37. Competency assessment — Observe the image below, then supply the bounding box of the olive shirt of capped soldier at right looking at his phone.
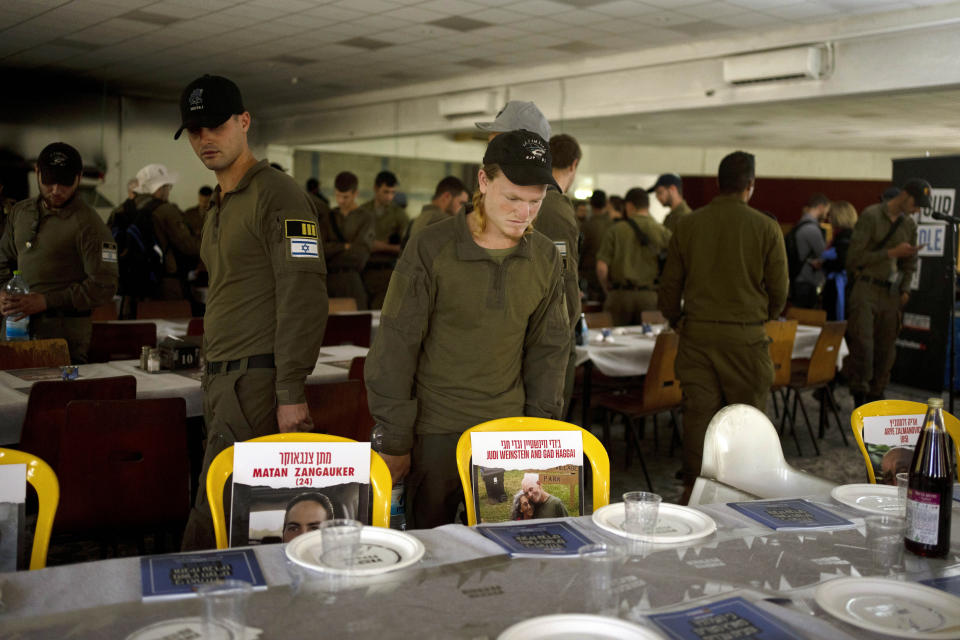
[847,202,917,293]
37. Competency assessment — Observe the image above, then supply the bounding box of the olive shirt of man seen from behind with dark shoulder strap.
[597,214,673,289]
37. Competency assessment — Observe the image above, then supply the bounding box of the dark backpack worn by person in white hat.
[110,199,164,298]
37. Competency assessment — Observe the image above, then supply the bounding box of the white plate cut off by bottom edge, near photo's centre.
[497,613,663,640]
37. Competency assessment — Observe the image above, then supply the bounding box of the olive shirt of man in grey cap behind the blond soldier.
[533,188,580,327]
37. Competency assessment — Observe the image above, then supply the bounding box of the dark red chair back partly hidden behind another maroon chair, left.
[20,376,137,470]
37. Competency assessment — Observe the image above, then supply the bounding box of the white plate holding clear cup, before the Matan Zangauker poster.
[284,527,425,576]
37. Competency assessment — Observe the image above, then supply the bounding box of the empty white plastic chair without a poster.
[690,404,836,504]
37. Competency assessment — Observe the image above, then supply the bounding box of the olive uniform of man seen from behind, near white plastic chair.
[659,195,788,485]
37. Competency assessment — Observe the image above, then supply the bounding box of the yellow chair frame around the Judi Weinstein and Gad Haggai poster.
[457,418,610,526]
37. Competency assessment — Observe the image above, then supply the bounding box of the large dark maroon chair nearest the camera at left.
[54,398,190,553]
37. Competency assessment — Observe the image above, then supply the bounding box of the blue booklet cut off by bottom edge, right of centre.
[650,598,802,640]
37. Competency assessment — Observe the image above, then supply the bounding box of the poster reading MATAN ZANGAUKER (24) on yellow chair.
[230,442,370,547]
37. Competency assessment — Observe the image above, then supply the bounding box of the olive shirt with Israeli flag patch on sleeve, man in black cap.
[200,160,327,404]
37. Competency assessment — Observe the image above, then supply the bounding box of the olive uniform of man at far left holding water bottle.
[0,197,118,364]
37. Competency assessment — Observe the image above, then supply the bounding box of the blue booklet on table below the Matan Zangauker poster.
[140,549,267,600]
